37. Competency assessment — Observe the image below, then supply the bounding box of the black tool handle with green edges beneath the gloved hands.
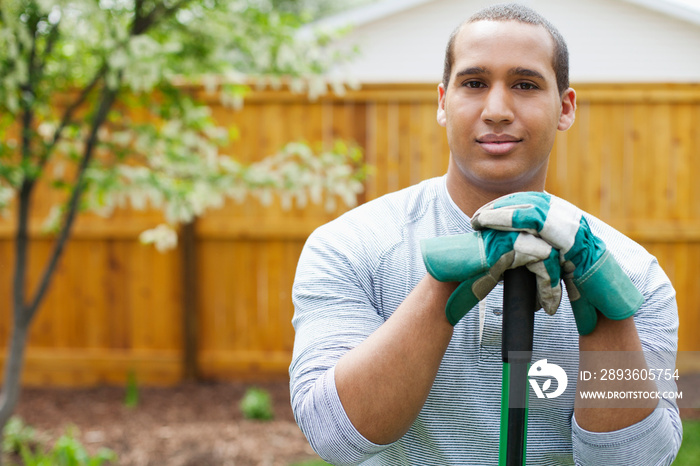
[501,267,537,466]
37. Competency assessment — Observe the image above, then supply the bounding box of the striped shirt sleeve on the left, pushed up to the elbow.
[290,224,394,465]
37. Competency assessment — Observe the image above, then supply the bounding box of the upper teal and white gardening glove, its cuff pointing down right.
[472,192,644,335]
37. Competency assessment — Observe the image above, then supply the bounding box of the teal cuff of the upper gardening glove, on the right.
[573,251,644,320]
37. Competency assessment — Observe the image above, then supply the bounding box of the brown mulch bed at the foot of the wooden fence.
[16,382,318,466]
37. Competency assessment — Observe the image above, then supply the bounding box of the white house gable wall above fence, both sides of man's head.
[328,0,700,83]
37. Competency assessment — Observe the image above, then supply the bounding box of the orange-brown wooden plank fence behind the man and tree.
[0,84,700,385]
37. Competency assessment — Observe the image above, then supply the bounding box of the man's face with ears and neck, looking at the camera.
[438,21,575,195]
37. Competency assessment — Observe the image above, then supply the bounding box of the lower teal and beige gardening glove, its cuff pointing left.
[421,230,561,325]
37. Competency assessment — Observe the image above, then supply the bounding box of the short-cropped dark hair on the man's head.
[442,3,569,94]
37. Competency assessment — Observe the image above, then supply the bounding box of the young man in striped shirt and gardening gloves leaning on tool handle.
[290,5,681,465]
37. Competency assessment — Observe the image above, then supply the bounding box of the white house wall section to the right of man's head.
[532,0,700,82]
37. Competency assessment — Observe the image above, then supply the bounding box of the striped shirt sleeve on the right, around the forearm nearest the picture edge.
[572,258,683,465]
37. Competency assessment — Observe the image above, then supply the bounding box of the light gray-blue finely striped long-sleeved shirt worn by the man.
[289,176,682,466]
